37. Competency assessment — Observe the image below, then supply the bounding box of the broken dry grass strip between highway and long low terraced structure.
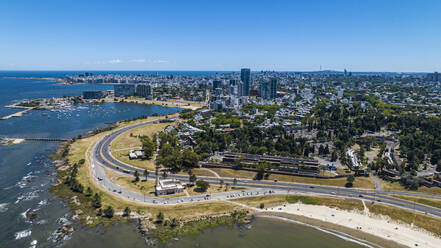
[210,168,375,189]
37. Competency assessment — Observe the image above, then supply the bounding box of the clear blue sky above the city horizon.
[0,0,441,72]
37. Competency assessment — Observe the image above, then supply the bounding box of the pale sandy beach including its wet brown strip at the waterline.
[256,203,441,248]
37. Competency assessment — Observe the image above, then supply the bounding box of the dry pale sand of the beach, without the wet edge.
[262,203,441,248]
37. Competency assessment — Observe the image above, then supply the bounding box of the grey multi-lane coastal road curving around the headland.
[90,117,441,218]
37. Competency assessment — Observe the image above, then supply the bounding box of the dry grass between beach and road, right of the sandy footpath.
[367,204,441,236]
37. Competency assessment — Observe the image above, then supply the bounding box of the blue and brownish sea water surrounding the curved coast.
[0,72,359,248]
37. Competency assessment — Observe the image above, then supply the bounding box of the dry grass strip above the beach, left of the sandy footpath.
[233,195,364,211]
